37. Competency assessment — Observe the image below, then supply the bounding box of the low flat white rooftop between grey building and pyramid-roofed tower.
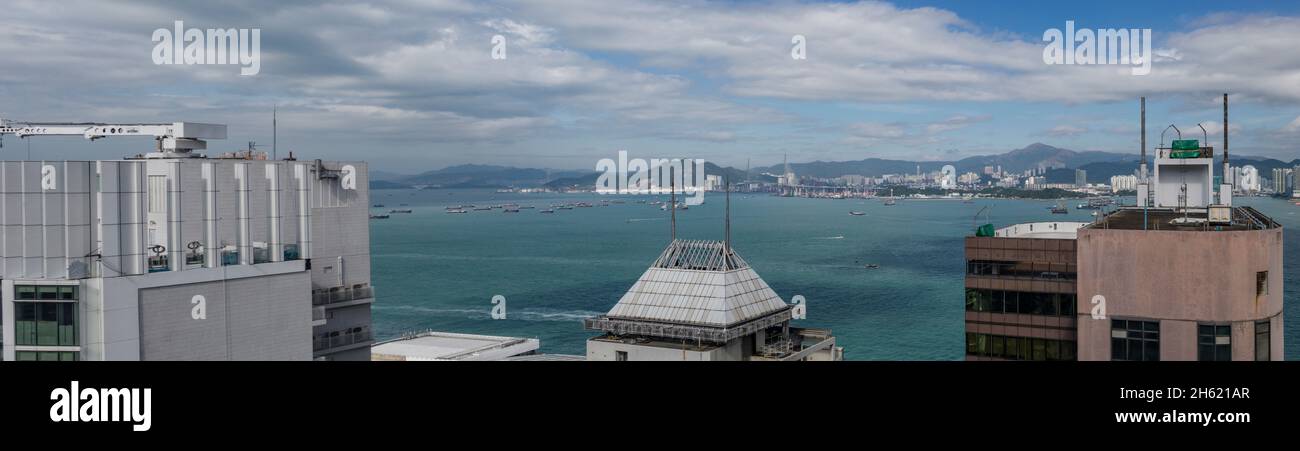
[371,331,541,360]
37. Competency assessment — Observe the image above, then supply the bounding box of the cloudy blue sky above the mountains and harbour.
[0,0,1300,173]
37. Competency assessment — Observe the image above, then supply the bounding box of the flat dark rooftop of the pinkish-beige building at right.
[1087,207,1282,231]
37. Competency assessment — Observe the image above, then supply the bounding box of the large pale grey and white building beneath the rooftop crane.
[0,157,373,360]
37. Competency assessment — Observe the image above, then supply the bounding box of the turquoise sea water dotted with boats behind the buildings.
[371,190,1300,360]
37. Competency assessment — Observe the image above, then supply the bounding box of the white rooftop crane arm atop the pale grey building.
[0,118,226,159]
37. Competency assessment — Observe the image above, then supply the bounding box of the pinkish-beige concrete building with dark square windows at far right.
[1076,207,1283,360]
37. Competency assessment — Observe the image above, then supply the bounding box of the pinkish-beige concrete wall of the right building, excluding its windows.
[1076,229,1284,360]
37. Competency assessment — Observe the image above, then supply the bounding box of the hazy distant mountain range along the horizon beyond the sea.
[371,143,1300,190]
